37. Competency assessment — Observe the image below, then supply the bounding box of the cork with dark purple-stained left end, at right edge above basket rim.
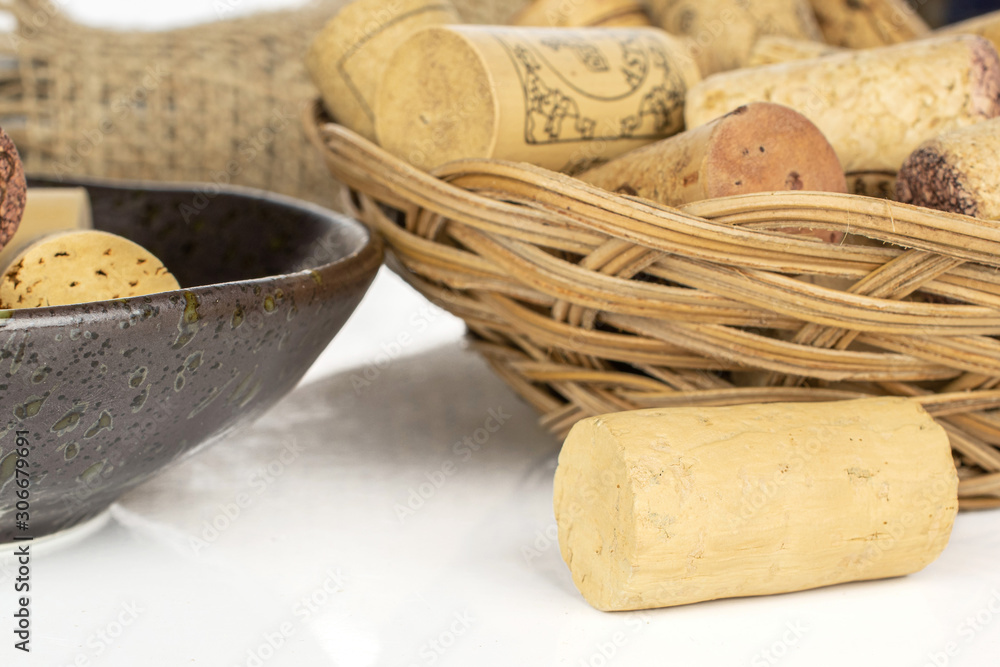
[896,118,1000,220]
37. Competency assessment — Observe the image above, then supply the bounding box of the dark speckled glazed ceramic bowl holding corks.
[0,180,382,543]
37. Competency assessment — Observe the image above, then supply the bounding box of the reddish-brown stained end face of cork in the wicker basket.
[705,102,847,197]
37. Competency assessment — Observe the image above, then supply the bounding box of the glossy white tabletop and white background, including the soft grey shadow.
[0,0,1000,667]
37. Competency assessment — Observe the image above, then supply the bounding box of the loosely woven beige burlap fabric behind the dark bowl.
[0,0,524,208]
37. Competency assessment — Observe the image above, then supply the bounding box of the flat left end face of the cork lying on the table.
[554,417,641,611]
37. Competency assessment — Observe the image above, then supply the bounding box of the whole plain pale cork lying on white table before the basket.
[554,398,958,611]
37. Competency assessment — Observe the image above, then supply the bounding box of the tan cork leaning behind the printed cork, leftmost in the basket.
[306,0,461,141]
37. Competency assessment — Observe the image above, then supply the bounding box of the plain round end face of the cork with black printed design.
[375,28,497,170]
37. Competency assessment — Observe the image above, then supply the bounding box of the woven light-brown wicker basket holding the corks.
[305,103,1000,509]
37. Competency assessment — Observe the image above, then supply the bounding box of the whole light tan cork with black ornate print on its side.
[376,26,700,172]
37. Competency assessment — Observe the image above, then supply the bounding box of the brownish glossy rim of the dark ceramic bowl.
[0,175,384,324]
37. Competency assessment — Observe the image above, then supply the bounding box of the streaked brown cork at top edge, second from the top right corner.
[809,0,930,49]
